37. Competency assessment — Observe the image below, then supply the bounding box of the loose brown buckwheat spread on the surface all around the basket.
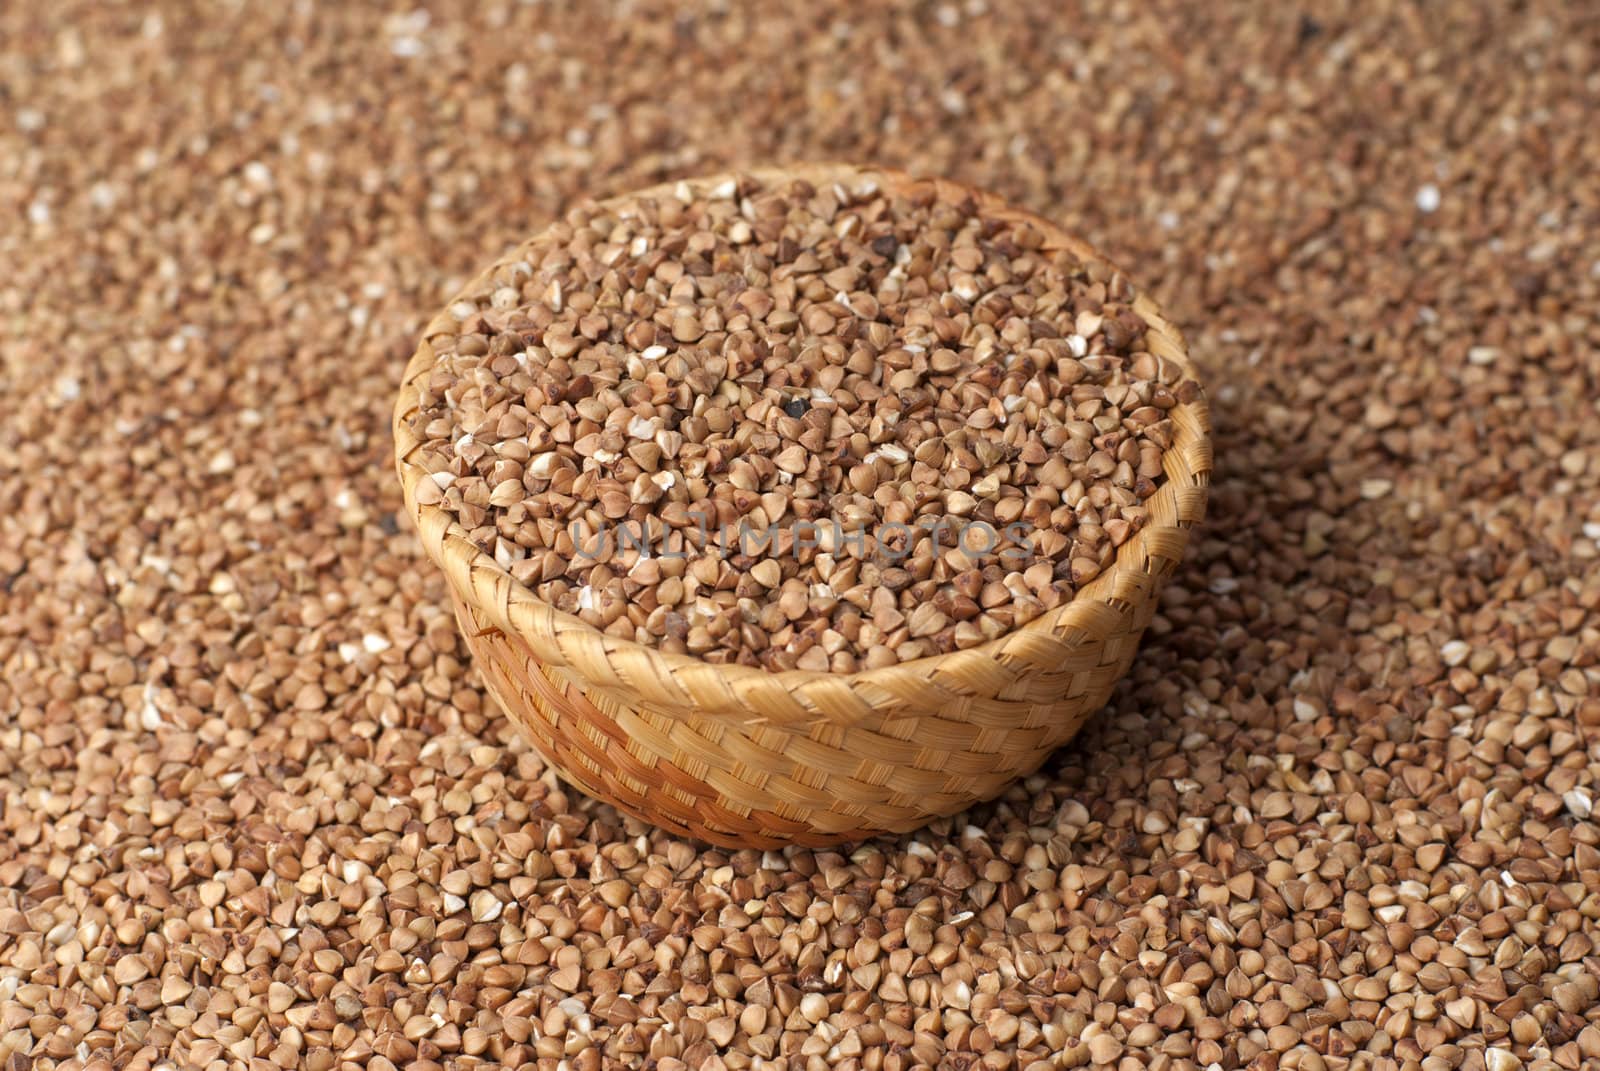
[0,0,1600,1071]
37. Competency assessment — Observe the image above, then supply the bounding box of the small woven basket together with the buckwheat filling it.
[394,165,1211,847]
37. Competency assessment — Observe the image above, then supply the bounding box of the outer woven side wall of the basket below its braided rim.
[454,596,1154,847]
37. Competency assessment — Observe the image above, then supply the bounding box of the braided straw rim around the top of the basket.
[392,162,1211,724]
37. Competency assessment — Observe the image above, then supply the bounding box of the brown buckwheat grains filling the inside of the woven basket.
[413,173,1197,662]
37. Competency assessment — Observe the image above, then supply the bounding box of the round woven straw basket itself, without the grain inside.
[394,165,1211,847]
